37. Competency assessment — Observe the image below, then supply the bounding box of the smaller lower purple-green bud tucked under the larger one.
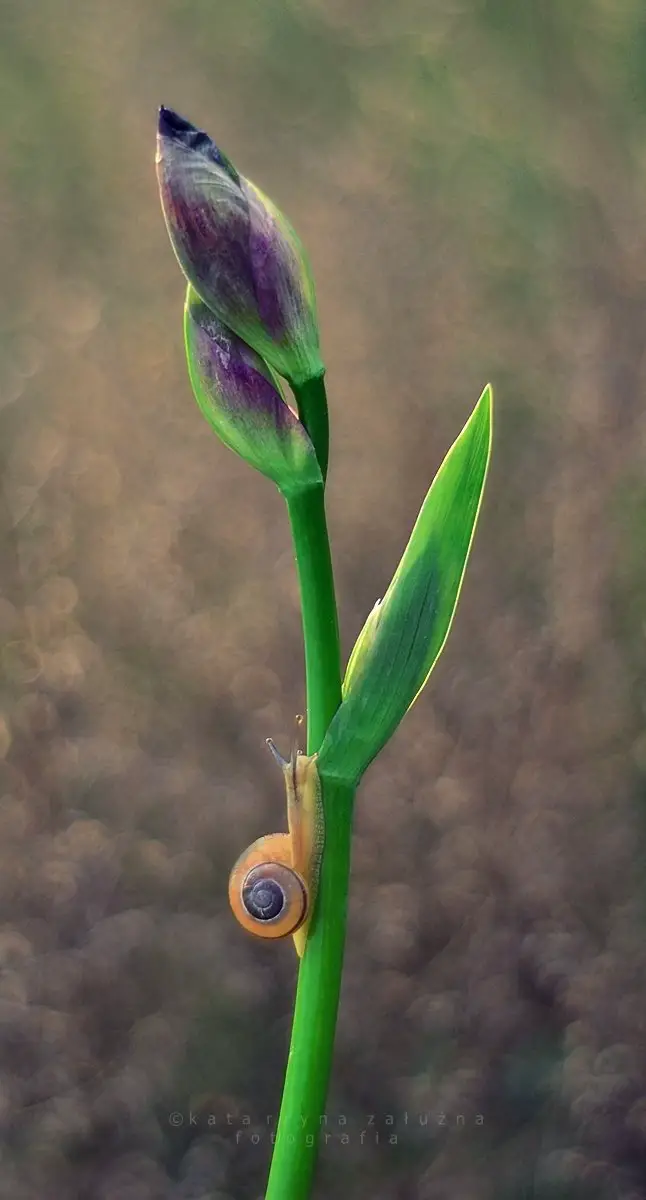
[184,286,323,496]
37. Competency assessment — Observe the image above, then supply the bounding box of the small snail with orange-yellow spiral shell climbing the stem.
[229,720,324,958]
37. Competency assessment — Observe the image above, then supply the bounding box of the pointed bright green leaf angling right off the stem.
[319,384,494,782]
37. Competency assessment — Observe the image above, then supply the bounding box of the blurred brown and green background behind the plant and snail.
[0,0,646,1200]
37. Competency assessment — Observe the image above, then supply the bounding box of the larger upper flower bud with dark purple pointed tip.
[156,108,324,384]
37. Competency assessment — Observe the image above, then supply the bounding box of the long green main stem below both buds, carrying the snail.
[265,486,354,1200]
